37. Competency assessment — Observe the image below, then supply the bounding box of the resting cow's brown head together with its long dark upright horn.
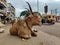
[26,2,41,26]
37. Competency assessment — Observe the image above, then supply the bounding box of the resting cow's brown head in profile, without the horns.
[26,14,41,27]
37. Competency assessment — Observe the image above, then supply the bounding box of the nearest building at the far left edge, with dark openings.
[0,0,7,21]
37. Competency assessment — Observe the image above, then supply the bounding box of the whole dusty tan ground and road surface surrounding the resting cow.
[0,23,60,45]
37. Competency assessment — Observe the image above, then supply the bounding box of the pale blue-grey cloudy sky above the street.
[7,0,60,17]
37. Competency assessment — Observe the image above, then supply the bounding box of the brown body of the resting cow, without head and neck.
[10,20,31,38]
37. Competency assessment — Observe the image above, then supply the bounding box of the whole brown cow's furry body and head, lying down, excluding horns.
[10,14,40,38]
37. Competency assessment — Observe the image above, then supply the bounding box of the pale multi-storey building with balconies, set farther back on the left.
[7,3,15,20]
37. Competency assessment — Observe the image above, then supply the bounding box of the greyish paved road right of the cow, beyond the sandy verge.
[35,23,60,38]
